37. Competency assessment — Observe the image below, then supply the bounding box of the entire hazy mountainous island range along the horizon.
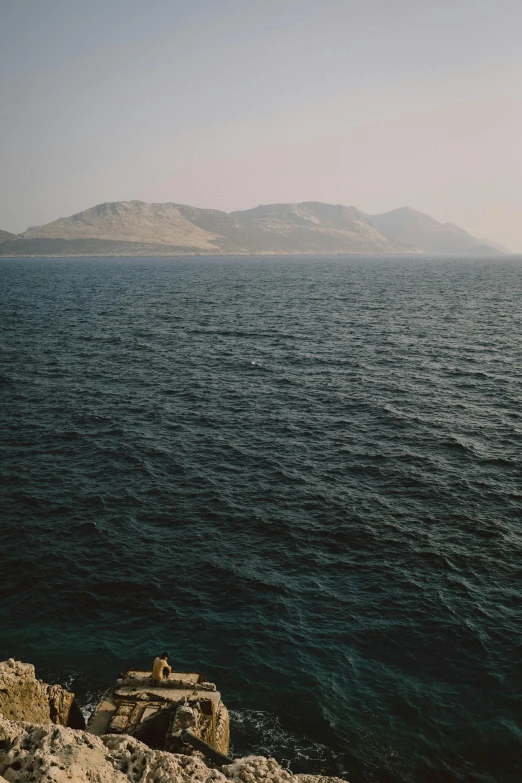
[0,201,509,257]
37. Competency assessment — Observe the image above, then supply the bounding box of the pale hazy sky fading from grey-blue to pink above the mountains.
[0,0,522,252]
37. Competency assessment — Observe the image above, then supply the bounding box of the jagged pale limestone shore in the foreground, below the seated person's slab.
[0,660,345,783]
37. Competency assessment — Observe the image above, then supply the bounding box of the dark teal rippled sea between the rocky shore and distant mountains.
[0,258,522,783]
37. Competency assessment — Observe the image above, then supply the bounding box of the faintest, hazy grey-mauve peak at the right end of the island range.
[368,207,502,255]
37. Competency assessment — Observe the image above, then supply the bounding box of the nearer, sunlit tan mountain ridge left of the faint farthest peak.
[0,201,408,255]
